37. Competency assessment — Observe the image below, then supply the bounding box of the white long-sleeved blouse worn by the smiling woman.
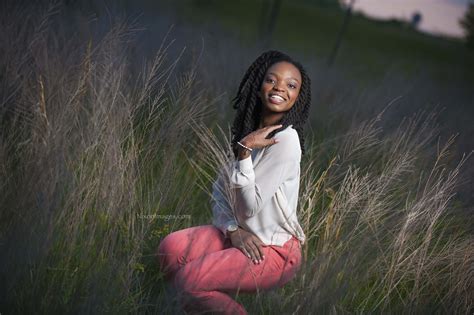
[211,125,305,246]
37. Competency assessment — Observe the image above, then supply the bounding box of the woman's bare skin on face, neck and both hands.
[229,61,301,264]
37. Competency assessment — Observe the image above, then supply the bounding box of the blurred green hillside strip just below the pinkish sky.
[174,0,474,83]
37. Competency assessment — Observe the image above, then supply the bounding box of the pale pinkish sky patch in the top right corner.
[344,0,474,37]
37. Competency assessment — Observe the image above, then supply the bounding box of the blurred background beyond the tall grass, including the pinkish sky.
[65,0,474,201]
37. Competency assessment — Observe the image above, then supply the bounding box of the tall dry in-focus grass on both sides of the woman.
[0,1,474,314]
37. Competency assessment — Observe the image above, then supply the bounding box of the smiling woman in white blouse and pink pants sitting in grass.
[158,51,311,314]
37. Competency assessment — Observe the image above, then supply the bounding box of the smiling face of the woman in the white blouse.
[260,61,302,113]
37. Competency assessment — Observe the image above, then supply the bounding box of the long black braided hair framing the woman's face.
[232,50,311,158]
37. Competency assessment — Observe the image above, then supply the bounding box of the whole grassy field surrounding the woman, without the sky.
[0,1,474,314]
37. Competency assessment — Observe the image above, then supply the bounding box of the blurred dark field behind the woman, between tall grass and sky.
[169,0,474,204]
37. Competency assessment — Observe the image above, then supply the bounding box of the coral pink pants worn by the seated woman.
[157,225,301,314]
